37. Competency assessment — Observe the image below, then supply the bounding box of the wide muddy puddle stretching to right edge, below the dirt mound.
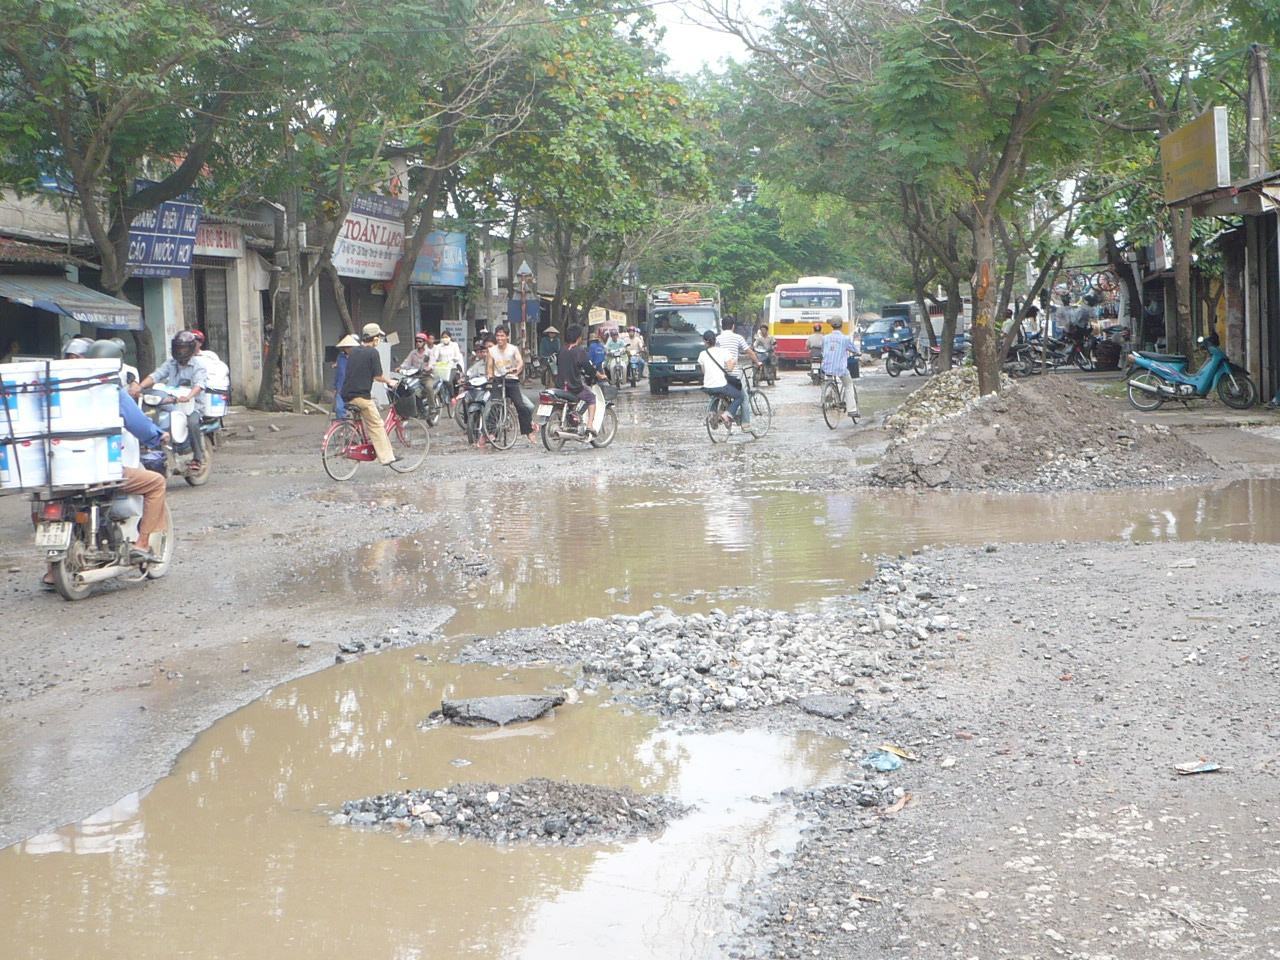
[296,480,1280,634]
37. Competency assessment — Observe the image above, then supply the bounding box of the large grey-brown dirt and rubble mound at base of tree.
[873,371,1219,490]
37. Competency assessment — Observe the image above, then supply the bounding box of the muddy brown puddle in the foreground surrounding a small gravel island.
[0,650,845,960]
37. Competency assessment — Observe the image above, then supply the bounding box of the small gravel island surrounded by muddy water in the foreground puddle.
[332,778,687,844]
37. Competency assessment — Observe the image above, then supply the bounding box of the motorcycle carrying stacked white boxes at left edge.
[31,484,174,600]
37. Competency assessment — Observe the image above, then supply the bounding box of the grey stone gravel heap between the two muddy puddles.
[465,562,954,714]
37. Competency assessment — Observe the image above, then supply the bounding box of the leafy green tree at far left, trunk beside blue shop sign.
[0,0,282,367]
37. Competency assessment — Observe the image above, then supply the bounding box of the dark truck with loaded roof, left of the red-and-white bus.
[643,283,721,394]
